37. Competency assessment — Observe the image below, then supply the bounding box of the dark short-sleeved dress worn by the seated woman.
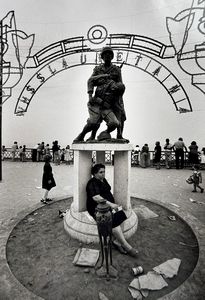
[86,177,127,228]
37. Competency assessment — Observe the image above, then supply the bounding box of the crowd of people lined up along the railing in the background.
[2,137,205,169]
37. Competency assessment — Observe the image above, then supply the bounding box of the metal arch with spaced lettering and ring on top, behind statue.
[14,25,192,116]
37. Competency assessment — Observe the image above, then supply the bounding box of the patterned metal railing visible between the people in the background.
[3,148,205,168]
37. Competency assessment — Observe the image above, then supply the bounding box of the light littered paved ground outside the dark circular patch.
[0,161,205,300]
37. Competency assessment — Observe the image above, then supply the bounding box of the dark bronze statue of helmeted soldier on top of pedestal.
[73,47,128,143]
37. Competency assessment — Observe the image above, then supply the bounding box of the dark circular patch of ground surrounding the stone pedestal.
[6,198,199,300]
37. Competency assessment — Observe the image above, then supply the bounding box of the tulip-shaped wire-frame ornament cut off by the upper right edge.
[166,0,205,94]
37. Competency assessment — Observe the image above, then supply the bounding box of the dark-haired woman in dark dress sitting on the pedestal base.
[86,164,138,257]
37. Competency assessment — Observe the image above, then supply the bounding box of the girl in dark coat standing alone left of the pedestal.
[41,155,56,204]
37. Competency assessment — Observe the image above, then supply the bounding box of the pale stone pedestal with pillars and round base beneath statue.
[64,143,138,243]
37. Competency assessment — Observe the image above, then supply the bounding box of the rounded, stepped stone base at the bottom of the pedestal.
[64,203,138,244]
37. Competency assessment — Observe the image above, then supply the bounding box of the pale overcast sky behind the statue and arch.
[0,0,205,150]
